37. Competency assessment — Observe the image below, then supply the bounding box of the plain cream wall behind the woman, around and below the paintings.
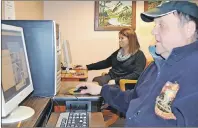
[44,1,152,81]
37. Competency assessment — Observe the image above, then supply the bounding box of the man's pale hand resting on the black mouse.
[76,82,102,95]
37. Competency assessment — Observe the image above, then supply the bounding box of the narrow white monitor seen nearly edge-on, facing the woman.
[62,40,72,68]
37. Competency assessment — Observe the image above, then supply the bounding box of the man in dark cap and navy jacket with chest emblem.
[77,1,198,127]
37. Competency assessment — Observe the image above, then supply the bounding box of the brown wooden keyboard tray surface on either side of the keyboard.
[46,112,105,128]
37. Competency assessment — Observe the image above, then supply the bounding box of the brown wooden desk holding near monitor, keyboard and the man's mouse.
[2,82,105,128]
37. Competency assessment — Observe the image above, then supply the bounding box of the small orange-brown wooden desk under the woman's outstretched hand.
[61,69,88,81]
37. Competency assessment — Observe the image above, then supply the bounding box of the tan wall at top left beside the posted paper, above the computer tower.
[2,1,44,20]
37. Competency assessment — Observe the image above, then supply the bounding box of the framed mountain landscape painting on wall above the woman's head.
[94,1,136,31]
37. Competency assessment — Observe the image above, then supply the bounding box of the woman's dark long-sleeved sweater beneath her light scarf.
[87,49,146,84]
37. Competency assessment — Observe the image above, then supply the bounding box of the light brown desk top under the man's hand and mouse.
[54,81,101,100]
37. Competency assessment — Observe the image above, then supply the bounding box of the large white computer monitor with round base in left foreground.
[1,24,34,124]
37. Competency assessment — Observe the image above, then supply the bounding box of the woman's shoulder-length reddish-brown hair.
[119,28,140,54]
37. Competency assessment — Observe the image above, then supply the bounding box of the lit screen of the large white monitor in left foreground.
[1,30,30,102]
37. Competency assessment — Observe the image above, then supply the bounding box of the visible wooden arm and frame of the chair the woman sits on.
[102,59,153,127]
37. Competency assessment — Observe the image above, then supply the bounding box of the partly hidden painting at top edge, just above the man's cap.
[144,0,163,11]
